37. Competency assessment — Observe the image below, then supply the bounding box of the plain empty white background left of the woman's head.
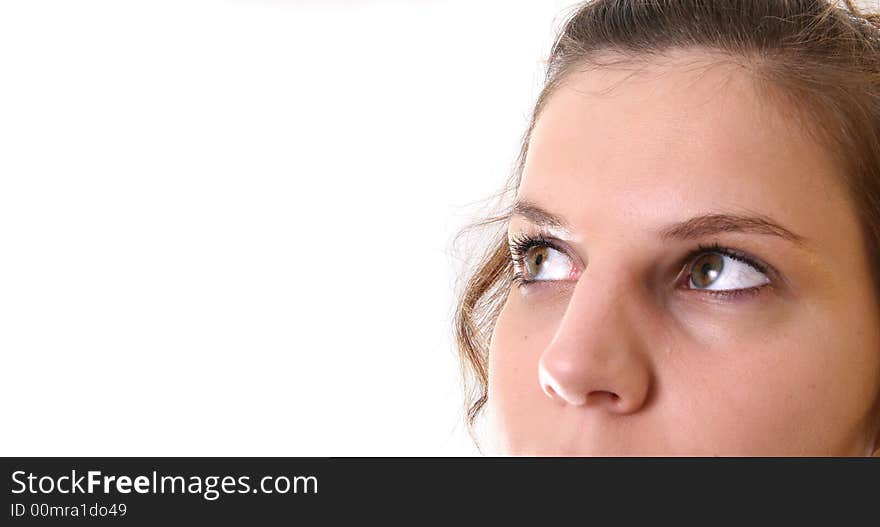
[0,0,572,456]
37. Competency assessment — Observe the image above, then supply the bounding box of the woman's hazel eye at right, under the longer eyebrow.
[688,250,770,291]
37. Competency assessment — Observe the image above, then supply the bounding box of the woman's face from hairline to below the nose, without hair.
[488,51,880,455]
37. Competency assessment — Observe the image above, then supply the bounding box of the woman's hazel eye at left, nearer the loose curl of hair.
[510,236,575,284]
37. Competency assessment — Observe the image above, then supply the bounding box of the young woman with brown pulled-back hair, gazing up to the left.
[456,0,880,456]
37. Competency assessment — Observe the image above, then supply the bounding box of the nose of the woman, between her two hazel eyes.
[538,271,652,414]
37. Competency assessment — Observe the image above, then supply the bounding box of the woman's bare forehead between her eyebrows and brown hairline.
[519,51,849,241]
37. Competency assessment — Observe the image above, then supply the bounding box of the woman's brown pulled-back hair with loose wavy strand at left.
[454,0,880,446]
